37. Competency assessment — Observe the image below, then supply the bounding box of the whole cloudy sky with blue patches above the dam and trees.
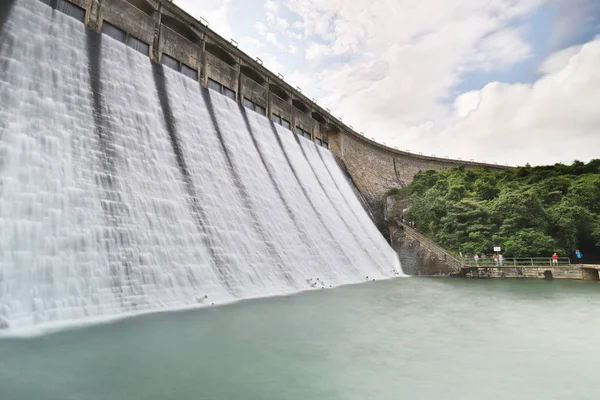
[175,0,600,165]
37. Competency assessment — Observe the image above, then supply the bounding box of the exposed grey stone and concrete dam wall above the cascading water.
[32,0,503,199]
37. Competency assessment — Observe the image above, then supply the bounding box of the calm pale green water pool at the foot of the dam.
[0,278,600,400]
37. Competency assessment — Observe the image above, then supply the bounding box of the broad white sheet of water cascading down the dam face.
[0,0,400,330]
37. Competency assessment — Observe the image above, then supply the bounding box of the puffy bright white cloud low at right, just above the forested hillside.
[436,39,600,165]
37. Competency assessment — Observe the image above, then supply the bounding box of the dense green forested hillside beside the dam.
[392,160,600,262]
